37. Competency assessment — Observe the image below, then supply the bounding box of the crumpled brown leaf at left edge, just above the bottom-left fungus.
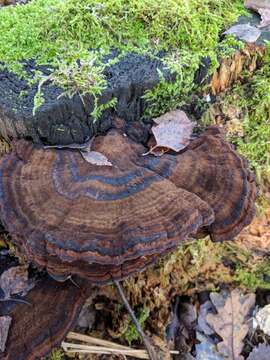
[0,266,33,299]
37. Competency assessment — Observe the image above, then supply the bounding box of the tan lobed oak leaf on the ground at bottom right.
[206,289,255,360]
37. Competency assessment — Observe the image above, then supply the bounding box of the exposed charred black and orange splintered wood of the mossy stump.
[0,14,270,144]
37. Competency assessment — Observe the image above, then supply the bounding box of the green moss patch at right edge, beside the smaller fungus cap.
[227,46,270,179]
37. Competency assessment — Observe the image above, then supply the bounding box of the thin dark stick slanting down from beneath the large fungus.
[113,280,158,360]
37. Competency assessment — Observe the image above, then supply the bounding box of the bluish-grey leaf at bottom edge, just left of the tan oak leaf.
[195,332,225,360]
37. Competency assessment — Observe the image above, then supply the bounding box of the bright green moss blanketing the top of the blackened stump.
[0,0,245,114]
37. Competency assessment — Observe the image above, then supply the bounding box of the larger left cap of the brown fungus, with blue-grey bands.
[0,130,214,283]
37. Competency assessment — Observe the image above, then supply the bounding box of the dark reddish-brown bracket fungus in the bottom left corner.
[0,276,91,360]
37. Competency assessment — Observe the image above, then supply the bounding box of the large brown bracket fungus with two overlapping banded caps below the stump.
[0,127,257,359]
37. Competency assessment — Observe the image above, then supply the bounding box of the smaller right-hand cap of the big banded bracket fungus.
[141,126,258,241]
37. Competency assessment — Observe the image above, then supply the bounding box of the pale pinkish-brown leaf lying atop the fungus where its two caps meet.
[150,110,194,155]
